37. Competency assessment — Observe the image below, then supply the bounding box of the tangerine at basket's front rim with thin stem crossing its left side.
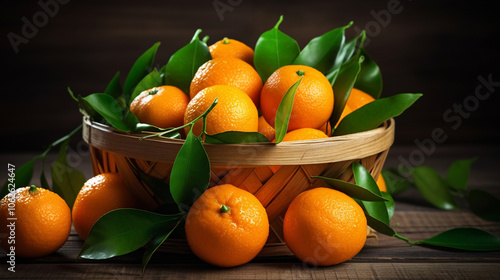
[184,85,259,136]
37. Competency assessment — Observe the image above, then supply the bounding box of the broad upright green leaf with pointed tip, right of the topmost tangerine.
[253,16,300,82]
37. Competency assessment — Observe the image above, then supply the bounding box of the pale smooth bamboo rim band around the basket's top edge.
[82,116,396,166]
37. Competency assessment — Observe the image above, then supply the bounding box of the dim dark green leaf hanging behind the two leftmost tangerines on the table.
[50,138,86,209]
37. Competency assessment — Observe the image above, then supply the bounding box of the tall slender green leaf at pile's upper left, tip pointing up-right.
[123,42,160,103]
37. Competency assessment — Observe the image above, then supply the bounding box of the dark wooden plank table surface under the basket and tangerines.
[0,145,500,280]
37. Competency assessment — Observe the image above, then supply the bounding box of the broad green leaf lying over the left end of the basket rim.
[83,93,130,132]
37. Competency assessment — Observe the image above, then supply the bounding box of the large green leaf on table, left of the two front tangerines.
[78,208,182,259]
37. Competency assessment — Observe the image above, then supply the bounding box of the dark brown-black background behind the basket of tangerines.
[0,0,500,152]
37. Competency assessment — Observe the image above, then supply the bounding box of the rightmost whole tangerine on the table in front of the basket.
[283,188,367,266]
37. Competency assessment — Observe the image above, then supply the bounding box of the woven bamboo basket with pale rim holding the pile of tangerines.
[83,118,395,256]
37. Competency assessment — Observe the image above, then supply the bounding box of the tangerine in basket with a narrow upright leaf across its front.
[260,65,333,131]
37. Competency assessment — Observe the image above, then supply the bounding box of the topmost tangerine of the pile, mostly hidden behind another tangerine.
[208,37,254,65]
